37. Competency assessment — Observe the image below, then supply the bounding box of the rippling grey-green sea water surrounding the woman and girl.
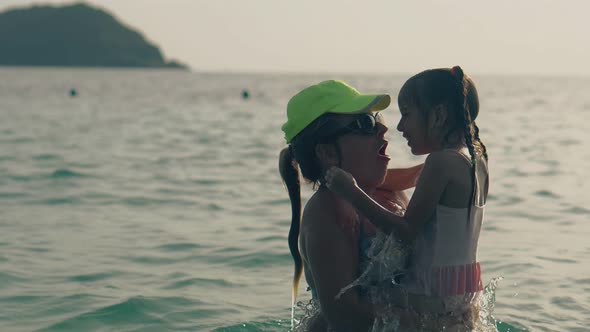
[0,68,590,331]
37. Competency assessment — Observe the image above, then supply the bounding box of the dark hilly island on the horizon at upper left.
[0,3,186,68]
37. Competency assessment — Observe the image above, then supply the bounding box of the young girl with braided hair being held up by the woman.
[326,66,489,330]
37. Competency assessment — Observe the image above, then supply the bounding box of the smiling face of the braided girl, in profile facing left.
[397,103,432,155]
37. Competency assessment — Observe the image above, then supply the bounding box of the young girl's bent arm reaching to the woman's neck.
[326,152,454,242]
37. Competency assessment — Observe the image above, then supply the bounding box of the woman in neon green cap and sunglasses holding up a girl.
[279,80,421,331]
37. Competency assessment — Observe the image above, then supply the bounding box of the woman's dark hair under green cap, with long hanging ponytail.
[279,113,342,305]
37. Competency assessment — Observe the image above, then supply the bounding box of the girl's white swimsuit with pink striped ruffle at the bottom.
[402,152,488,297]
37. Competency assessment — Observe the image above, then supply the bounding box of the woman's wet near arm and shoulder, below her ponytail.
[302,191,374,331]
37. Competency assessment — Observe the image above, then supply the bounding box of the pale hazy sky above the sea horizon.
[0,0,590,76]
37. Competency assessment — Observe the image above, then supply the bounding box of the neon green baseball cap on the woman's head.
[281,80,391,143]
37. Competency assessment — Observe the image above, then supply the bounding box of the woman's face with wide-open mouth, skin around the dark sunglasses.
[336,113,390,190]
